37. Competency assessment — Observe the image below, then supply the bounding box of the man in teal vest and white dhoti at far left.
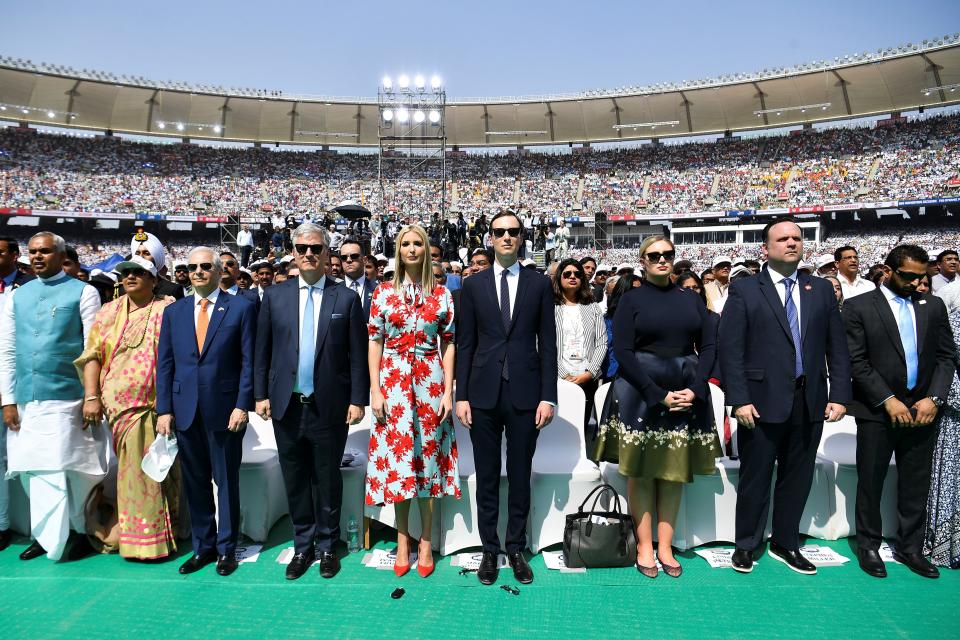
[0,232,108,560]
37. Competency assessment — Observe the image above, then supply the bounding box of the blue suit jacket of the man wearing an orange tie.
[157,291,257,431]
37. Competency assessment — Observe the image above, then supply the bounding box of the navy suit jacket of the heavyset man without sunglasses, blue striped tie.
[719,267,853,423]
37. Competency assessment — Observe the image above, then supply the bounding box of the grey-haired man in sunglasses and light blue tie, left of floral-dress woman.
[254,223,370,580]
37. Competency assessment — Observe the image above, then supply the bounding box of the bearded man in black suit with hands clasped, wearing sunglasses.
[843,244,956,578]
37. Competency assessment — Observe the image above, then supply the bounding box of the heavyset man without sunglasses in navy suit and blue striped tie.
[719,219,852,574]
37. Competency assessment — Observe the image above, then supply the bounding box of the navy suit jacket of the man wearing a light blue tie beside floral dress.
[254,278,370,428]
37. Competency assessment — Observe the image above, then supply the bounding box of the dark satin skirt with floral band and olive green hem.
[591,352,723,483]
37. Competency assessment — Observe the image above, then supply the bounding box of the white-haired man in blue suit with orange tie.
[157,247,257,576]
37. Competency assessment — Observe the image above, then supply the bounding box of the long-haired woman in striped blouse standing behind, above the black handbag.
[553,258,607,437]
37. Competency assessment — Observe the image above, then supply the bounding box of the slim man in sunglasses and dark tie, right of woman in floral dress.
[457,211,557,584]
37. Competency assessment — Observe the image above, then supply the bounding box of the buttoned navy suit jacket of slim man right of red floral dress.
[457,267,557,410]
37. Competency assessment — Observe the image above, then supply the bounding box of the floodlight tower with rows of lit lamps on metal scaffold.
[377,73,447,219]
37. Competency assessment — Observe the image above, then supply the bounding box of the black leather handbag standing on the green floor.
[563,484,637,569]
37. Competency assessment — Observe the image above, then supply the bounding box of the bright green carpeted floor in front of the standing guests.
[0,520,960,640]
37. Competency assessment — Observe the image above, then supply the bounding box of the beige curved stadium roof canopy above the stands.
[0,34,960,147]
